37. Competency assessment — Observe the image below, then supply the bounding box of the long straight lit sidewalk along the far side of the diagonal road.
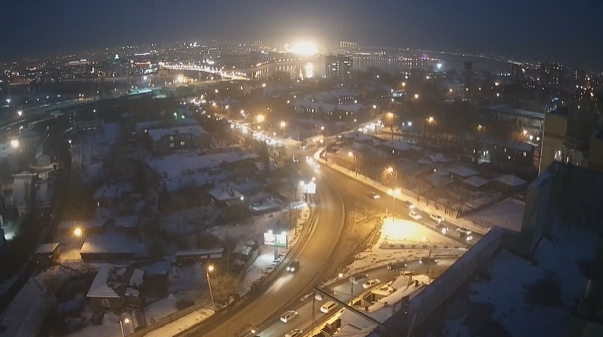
[314,150,492,235]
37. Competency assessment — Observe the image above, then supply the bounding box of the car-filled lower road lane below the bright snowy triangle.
[256,258,457,337]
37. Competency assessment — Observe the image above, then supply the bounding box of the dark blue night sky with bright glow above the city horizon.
[0,0,603,69]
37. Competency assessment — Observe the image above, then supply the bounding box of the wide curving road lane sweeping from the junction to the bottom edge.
[196,171,344,337]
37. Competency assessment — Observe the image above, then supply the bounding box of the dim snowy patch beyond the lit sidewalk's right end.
[465,198,525,232]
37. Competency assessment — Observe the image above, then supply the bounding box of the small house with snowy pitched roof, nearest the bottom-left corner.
[86,265,144,311]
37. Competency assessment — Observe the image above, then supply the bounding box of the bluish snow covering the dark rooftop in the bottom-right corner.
[462,225,597,336]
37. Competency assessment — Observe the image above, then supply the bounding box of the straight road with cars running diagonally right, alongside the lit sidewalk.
[321,165,482,245]
